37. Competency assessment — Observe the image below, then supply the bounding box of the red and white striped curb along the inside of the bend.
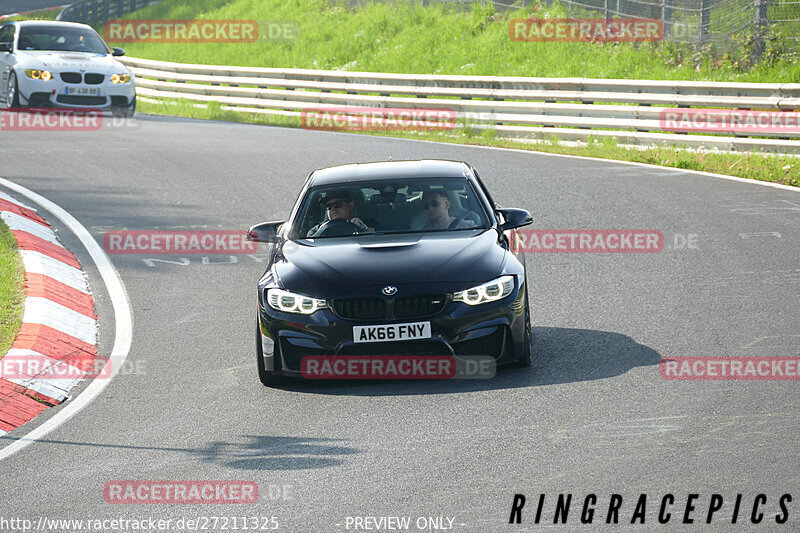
[0,192,97,436]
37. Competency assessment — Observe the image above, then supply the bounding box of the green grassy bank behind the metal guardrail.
[109,0,800,82]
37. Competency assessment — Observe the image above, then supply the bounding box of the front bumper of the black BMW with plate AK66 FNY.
[258,283,526,376]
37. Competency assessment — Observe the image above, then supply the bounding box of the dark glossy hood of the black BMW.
[273,230,507,297]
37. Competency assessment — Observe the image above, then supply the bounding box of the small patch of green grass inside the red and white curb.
[0,220,25,357]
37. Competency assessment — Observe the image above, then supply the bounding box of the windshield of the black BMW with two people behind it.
[293,178,489,239]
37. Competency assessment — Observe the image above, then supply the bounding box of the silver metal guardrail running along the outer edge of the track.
[121,57,800,154]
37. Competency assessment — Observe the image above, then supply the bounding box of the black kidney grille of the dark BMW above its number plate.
[333,294,447,320]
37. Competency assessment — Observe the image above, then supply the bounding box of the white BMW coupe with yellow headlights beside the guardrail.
[0,21,136,117]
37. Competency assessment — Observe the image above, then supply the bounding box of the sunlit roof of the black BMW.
[312,159,470,185]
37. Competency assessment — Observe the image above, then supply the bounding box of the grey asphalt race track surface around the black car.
[0,117,800,532]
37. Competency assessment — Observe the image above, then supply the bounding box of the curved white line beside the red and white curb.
[0,178,133,461]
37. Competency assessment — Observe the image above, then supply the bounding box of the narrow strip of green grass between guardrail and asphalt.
[137,100,800,187]
